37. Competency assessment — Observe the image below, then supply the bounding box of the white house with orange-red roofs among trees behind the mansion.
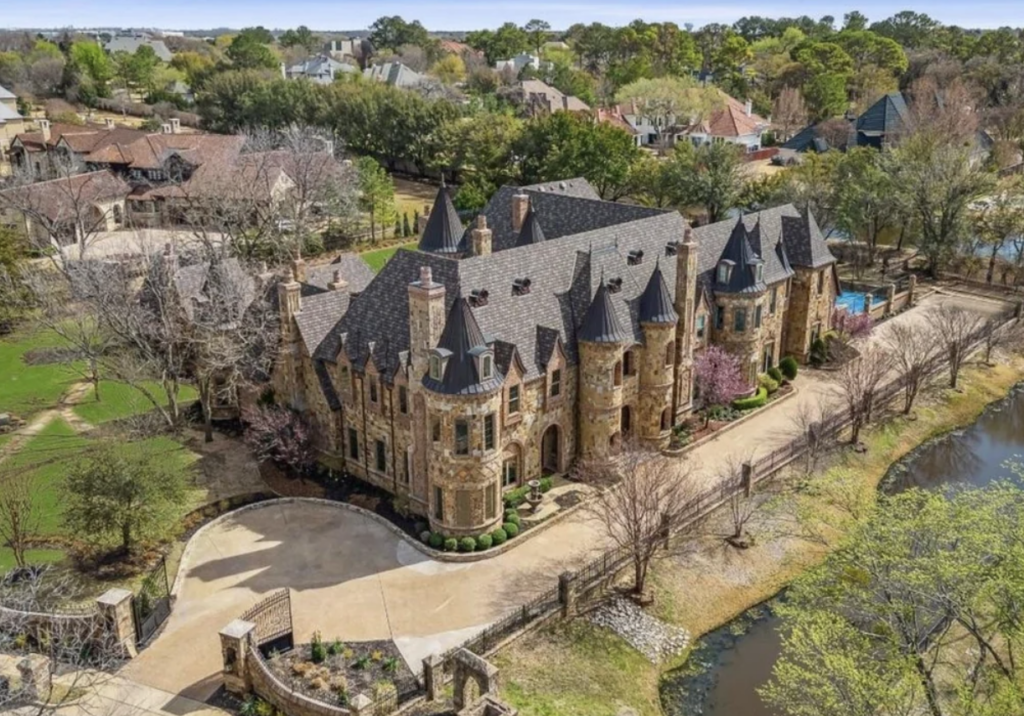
[601,91,770,153]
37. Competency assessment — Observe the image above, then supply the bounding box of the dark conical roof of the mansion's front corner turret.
[423,296,504,395]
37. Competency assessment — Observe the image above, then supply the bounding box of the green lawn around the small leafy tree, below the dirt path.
[0,418,205,573]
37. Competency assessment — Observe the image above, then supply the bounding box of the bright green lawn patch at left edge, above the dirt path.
[0,331,79,419]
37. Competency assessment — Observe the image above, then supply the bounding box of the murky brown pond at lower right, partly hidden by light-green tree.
[662,386,1024,716]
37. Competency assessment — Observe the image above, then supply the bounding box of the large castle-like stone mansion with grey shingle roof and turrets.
[273,179,837,537]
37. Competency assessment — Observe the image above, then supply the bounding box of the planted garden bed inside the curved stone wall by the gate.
[267,639,419,706]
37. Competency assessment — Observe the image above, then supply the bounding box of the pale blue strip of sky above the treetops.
[0,0,1024,31]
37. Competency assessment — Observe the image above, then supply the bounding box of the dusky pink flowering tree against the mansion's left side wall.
[242,406,316,477]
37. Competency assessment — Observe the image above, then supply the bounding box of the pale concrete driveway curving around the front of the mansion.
[125,295,1005,700]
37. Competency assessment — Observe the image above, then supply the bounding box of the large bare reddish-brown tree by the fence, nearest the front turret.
[578,443,695,597]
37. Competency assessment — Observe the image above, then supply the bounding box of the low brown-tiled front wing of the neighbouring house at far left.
[0,171,131,247]
